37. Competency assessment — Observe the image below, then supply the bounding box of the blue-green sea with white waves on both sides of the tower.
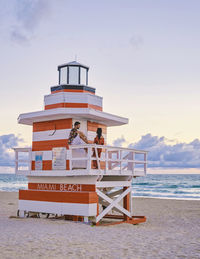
[0,174,200,200]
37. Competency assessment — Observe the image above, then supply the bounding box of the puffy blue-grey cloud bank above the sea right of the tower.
[121,134,200,168]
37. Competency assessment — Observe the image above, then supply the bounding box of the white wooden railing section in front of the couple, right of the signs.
[69,144,148,175]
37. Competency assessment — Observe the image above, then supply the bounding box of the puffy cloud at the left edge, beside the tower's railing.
[0,134,23,166]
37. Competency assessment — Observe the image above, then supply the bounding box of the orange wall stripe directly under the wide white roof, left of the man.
[33,119,72,132]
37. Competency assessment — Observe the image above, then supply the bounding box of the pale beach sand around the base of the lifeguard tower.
[0,192,200,259]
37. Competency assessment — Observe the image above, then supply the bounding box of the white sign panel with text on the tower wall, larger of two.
[52,147,66,170]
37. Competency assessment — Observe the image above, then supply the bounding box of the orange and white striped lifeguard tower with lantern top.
[14,61,147,225]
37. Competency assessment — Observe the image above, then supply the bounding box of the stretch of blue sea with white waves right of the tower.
[132,174,200,200]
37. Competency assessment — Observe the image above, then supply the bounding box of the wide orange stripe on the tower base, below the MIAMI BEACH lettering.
[19,190,98,204]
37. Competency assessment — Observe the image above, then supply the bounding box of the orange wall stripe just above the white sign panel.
[32,139,68,151]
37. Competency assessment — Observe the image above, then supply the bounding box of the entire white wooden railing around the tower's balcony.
[13,144,148,176]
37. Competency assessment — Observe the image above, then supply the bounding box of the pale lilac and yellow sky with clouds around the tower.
[0,0,200,174]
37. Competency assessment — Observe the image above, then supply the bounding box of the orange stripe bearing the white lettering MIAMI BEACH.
[28,183,96,192]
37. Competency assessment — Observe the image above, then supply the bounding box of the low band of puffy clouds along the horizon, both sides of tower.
[0,134,200,168]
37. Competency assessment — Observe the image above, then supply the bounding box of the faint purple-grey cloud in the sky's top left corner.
[0,0,53,44]
